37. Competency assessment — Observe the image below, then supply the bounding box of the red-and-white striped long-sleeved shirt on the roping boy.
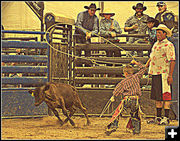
[113,63,146,96]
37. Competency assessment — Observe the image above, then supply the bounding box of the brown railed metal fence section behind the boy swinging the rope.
[72,34,154,115]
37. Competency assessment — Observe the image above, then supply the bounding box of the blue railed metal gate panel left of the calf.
[1,30,49,117]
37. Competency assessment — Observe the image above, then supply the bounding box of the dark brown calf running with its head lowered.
[29,82,90,126]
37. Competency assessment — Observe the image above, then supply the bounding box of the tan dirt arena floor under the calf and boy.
[1,116,178,140]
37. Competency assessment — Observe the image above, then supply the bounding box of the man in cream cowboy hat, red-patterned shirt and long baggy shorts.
[147,24,176,125]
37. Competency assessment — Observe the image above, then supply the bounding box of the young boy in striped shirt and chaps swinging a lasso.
[105,59,149,136]
